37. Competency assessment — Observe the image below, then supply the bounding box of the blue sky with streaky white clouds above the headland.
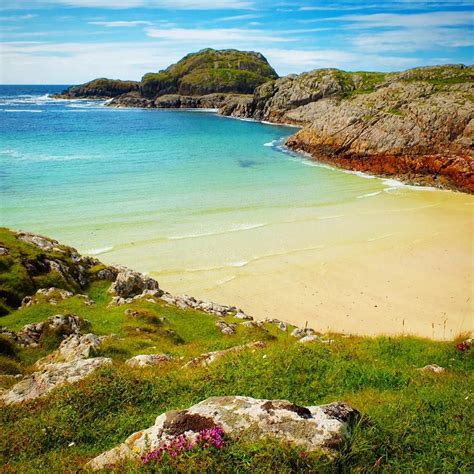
[0,0,474,84]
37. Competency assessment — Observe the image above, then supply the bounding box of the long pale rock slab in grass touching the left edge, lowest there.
[0,357,112,405]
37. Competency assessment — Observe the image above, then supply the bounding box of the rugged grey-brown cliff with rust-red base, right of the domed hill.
[220,65,474,192]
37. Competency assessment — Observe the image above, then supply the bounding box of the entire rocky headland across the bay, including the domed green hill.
[53,49,474,193]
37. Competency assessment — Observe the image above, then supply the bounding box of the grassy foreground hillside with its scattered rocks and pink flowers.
[0,229,474,473]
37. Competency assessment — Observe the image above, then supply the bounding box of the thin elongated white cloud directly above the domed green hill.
[145,28,292,42]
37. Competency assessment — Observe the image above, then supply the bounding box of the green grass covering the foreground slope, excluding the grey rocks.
[0,229,474,472]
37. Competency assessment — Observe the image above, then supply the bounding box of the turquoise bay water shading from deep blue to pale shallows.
[0,86,386,272]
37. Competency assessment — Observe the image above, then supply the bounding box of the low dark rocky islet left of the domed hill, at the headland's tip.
[53,78,140,100]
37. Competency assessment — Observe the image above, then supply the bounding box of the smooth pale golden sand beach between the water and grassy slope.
[147,188,474,340]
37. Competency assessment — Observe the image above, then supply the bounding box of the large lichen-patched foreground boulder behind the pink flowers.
[85,396,359,470]
